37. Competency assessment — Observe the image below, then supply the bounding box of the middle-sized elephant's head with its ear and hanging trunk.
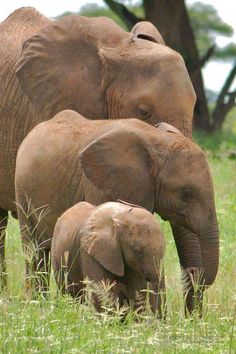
[80,119,219,311]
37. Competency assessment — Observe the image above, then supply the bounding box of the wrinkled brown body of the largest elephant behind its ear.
[0,8,51,211]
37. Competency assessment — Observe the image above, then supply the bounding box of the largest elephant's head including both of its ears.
[16,16,195,136]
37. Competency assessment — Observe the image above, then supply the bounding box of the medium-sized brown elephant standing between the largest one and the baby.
[16,111,219,311]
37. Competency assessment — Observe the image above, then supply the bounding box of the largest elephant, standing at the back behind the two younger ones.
[0,8,195,284]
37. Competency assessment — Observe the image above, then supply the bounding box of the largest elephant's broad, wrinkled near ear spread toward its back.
[16,16,103,118]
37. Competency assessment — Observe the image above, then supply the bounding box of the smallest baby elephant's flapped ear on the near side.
[82,216,124,277]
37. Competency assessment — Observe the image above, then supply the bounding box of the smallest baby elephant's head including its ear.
[82,202,165,286]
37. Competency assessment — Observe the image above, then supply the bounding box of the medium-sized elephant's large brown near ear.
[80,123,155,211]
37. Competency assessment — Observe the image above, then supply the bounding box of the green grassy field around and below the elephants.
[0,133,236,354]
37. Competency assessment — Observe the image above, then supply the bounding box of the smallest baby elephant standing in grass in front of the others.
[51,202,165,317]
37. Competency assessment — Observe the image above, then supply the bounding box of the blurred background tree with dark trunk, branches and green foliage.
[59,0,236,132]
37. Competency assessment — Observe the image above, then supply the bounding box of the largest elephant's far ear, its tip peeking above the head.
[131,21,165,45]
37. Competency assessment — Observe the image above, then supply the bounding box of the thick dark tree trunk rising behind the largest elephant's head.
[143,0,210,132]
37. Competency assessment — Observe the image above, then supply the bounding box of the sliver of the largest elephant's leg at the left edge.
[0,209,8,289]
